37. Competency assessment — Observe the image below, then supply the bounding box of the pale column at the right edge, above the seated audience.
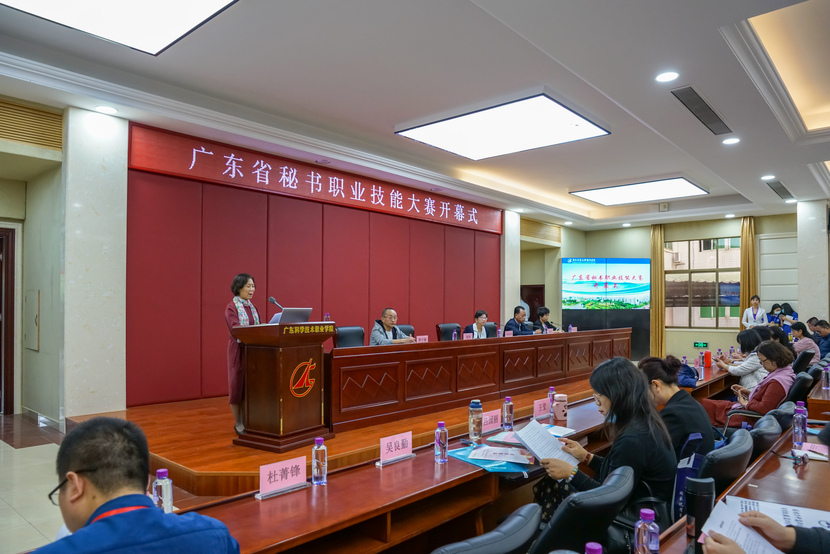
[798,200,830,321]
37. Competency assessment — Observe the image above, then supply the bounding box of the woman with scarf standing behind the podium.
[225,273,259,435]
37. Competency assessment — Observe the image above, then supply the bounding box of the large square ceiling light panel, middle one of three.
[395,93,608,160]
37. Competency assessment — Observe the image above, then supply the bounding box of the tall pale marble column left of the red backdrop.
[64,108,128,417]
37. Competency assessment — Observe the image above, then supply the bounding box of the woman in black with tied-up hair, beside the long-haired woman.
[638,356,715,461]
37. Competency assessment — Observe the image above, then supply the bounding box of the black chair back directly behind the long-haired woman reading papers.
[529,466,635,554]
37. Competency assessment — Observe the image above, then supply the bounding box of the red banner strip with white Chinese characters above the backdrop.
[129,124,502,234]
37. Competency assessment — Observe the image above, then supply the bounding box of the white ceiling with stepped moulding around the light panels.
[0,0,830,229]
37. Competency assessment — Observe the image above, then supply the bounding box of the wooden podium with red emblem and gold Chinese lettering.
[231,321,334,453]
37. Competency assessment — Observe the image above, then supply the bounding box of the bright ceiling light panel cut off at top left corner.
[0,0,237,56]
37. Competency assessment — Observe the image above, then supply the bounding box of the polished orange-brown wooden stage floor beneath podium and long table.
[71,379,591,496]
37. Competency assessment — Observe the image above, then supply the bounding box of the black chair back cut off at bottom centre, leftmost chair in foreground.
[432,504,542,554]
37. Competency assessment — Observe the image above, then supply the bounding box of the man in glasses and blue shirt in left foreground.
[36,417,239,554]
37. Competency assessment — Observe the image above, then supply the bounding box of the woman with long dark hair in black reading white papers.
[533,357,677,521]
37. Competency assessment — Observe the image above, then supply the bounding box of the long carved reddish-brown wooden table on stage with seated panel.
[326,327,631,432]
